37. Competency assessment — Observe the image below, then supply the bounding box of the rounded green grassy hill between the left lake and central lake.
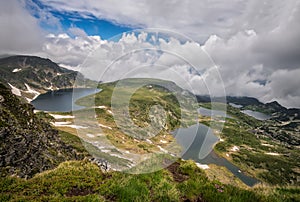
[75,79,195,154]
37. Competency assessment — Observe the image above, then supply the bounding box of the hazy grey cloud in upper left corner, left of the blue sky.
[0,0,43,54]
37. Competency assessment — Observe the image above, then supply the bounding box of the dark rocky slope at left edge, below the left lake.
[0,84,78,178]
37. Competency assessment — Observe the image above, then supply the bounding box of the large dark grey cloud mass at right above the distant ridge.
[203,1,300,107]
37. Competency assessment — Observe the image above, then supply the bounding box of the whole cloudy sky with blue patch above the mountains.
[0,0,300,108]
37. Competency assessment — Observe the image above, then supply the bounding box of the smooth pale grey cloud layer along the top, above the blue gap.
[35,0,246,41]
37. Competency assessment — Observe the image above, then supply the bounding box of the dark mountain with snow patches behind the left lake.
[0,55,92,101]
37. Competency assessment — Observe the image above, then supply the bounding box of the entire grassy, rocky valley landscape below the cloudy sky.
[0,55,300,201]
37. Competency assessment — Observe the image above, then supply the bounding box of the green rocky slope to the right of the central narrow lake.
[201,103,300,186]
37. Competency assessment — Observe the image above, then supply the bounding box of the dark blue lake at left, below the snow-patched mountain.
[31,88,100,112]
